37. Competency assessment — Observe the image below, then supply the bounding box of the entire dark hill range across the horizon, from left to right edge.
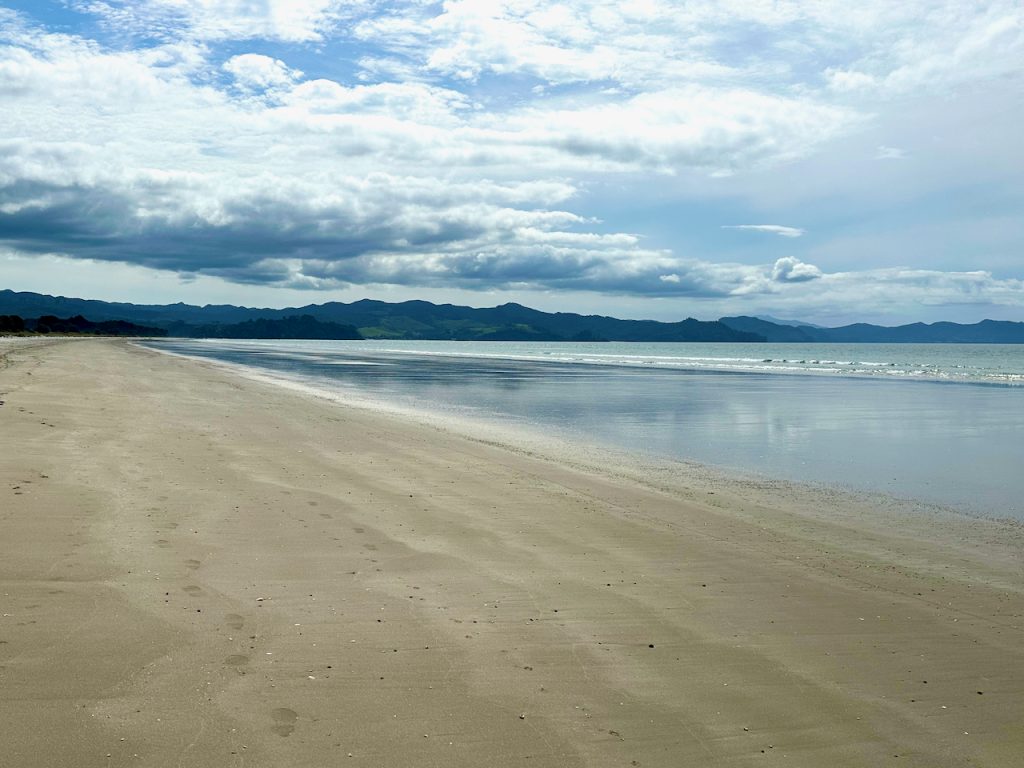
[0,290,1024,344]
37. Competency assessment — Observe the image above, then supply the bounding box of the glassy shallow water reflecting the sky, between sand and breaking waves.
[151,342,1024,518]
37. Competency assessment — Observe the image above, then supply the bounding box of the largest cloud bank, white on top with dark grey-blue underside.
[0,20,845,291]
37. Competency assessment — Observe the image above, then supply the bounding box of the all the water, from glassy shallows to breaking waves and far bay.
[152,340,1024,519]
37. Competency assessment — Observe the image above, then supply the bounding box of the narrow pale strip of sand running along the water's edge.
[142,342,1024,602]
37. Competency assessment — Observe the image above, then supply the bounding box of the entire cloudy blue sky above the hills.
[0,0,1024,325]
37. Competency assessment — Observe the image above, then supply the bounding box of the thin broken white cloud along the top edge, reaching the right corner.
[353,0,1024,102]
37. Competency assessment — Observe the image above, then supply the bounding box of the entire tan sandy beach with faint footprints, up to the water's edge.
[0,340,1024,768]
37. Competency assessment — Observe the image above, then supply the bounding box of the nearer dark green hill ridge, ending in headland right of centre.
[0,291,763,342]
